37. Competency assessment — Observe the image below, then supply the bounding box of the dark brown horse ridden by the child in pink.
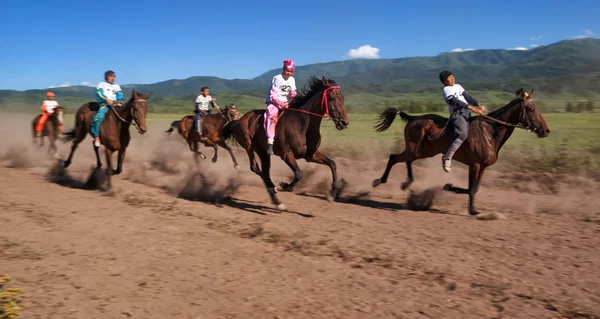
[223,77,350,209]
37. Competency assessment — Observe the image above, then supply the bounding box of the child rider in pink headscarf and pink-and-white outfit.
[264,60,297,155]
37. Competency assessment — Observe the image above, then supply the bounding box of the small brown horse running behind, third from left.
[165,104,240,169]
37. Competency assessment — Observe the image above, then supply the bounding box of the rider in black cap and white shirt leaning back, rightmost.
[440,71,486,172]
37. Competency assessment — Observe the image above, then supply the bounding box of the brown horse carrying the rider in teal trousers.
[61,90,152,188]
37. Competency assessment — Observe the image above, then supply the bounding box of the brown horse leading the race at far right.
[373,88,550,215]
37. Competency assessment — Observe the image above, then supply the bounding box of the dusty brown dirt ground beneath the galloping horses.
[0,114,600,319]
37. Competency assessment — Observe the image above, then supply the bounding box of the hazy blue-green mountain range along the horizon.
[0,38,600,103]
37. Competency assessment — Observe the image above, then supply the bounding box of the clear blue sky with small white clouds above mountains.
[0,0,600,90]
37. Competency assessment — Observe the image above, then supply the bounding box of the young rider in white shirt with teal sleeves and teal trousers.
[90,71,125,147]
